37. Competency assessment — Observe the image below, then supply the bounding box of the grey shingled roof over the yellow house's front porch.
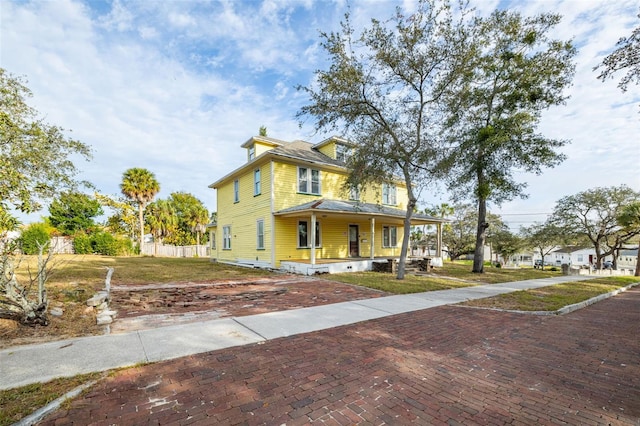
[274,199,449,225]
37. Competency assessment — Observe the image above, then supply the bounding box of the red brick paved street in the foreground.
[42,288,640,425]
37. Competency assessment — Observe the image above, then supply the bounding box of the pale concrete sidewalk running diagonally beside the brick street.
[0,276,589,389]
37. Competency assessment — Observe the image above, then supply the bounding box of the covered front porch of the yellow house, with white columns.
[274,199,446,275]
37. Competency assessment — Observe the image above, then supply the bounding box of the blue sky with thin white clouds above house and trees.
[0,0,640,229]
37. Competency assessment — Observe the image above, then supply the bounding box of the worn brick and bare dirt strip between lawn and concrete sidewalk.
[0,275,387,348]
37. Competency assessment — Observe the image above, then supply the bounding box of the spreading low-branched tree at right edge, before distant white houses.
[552,185,640,268]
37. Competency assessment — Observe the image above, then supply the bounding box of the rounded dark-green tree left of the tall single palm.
[49,192,103,235]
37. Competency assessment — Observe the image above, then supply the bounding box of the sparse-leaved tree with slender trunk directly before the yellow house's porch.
[298,0,466,279]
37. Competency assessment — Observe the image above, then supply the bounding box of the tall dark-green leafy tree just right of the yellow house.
[442,10,576,272]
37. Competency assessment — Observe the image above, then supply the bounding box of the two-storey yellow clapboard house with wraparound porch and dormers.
[208,136,446,274]
